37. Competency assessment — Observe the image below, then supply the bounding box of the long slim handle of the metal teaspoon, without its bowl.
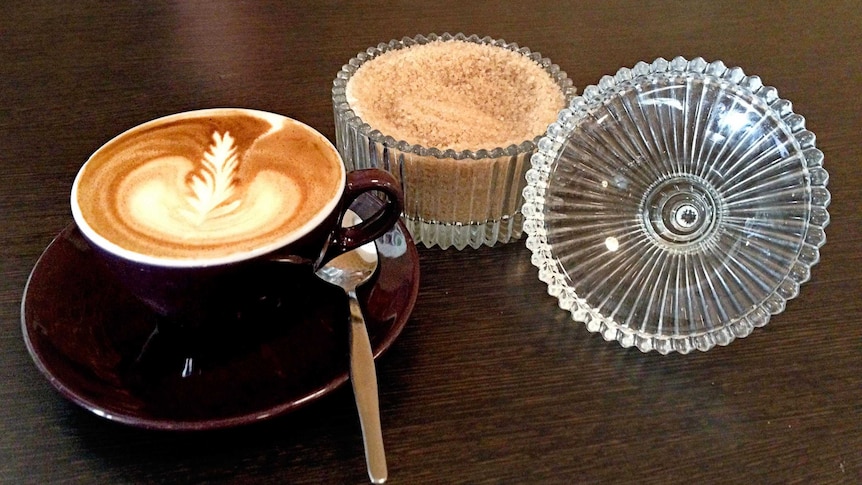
[347,291,387,483]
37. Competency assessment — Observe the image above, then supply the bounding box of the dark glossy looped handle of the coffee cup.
[322,168,404,261]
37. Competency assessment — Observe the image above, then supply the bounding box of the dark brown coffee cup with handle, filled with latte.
[71,108,403,326]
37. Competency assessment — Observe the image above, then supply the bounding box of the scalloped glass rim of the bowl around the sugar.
[332,32,576,160]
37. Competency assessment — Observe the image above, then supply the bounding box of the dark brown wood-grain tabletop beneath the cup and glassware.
[0,0,862,484]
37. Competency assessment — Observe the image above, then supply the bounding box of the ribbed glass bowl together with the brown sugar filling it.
[332,34,574,249]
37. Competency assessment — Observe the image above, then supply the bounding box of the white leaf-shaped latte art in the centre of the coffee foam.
[186,132,241,224]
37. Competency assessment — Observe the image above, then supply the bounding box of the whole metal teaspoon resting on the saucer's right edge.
[317,213,387,483]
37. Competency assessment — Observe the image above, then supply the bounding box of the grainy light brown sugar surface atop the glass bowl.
[346,40,565,151]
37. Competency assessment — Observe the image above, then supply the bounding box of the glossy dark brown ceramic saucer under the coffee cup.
[21,197,419,430]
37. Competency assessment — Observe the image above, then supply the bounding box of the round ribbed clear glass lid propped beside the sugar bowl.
[523,57,830,354]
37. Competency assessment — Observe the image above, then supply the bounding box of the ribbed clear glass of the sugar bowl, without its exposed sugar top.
[332,33,575,249]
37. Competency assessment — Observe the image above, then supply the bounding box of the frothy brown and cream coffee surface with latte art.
[72,109,344,262]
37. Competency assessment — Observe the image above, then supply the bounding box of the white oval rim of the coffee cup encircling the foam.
[70,107,347,268]
